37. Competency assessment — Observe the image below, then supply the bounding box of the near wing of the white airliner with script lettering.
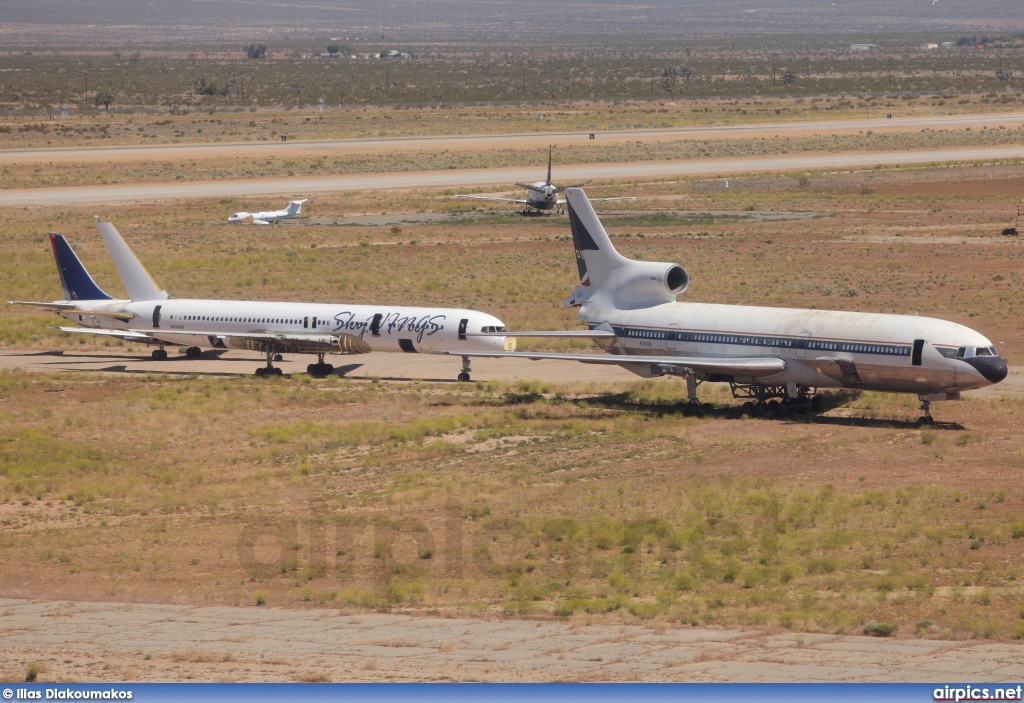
[60,327,370,354]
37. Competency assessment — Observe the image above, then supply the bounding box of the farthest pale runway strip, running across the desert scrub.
[0,113,1024,164]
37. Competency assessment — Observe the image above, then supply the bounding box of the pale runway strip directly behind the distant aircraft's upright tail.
[6,145,1024,207]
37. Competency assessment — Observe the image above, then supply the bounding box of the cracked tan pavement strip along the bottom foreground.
[0,600,1024,682]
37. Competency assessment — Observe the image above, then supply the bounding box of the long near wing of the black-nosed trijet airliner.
[431,350,785,377]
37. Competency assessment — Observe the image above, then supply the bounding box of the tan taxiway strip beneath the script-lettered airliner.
[0,348,1024,398]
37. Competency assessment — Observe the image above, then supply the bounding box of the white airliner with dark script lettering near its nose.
[11,218,515,381]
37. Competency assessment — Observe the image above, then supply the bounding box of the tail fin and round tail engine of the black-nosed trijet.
[563,187,689,310]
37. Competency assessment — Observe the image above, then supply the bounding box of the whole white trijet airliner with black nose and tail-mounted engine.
[438,188,1007,423]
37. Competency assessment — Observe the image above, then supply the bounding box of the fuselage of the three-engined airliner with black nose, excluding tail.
[580,303,1007,395]
